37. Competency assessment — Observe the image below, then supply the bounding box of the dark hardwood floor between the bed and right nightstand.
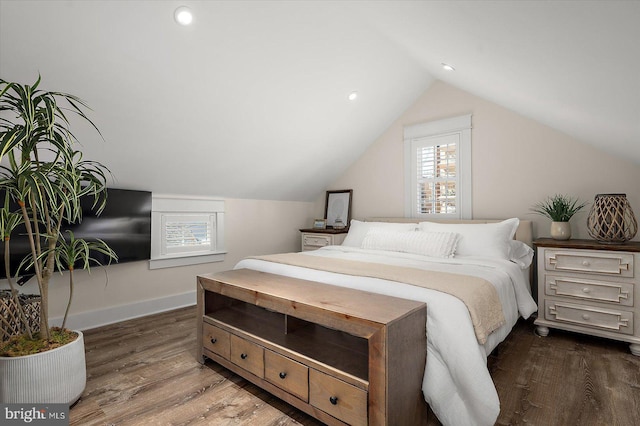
[488,314,640,426]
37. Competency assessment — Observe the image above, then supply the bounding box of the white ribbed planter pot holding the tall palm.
[0,331,87,405]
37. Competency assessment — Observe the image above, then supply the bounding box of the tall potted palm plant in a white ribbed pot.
[0,77,117,403]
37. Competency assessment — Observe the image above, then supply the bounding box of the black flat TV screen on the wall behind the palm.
[0,188,151,278]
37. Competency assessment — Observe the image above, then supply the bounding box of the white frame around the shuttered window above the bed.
[404,114,472,219]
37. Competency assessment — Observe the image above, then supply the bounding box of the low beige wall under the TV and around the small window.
[0,199,314,329]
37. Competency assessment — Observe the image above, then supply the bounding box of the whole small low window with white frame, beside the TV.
[150,195,226,269]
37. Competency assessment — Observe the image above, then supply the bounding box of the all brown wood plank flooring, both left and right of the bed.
[70,307,640,426]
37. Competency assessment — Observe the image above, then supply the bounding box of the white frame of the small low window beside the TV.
[149,194,227,269]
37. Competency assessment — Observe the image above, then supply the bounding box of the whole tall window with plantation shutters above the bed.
[404,115,471,219]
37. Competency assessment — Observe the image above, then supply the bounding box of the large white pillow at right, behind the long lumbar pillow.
[420,218,520,260]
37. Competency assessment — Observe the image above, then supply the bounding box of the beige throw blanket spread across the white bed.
[252,253,505,344]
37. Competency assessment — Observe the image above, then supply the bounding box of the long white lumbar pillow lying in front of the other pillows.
[362,228,458,257]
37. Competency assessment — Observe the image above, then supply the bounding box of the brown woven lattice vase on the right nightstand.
[587,194,638,243]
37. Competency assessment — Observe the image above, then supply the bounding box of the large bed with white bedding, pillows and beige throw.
[235,218,537,425]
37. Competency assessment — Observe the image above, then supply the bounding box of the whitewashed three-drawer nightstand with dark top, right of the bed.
[534,238,640,356]
